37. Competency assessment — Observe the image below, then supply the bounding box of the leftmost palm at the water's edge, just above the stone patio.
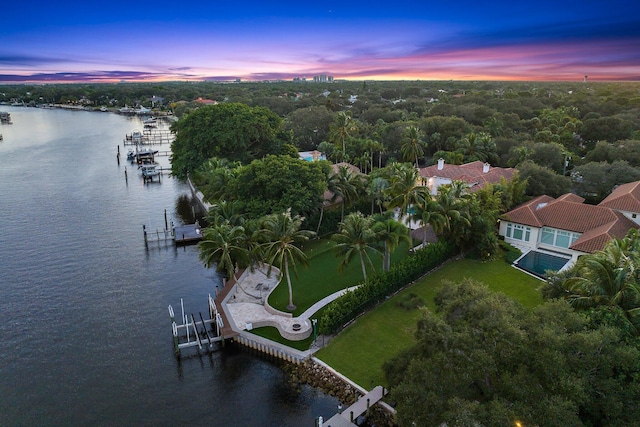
[198,223,248,279]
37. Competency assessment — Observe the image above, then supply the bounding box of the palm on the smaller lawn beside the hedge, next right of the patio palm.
[332,212,378,283]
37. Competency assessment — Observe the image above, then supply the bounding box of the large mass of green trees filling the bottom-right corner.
[385,280,640,426]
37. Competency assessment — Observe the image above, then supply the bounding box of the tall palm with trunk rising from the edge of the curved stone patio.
[262,209,315,311]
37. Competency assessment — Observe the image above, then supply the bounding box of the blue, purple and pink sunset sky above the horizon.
[0,0,640,83]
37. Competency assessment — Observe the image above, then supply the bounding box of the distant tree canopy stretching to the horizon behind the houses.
[6,81,640,202]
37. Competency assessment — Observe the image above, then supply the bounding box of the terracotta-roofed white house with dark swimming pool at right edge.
[499,185,640,275]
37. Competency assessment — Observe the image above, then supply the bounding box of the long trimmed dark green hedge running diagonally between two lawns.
[318,242,456,334]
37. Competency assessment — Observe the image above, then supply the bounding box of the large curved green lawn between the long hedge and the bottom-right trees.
[316,259,543,388]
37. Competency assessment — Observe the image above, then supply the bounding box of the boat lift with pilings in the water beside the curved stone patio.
[169,294,224,356]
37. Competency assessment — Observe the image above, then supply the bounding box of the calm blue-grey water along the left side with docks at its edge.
[0,106,338,426]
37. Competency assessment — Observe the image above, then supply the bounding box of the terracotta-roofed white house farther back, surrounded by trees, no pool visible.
[419,159,516,194]
